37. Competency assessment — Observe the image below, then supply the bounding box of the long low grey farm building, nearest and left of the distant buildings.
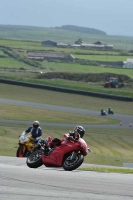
[27,51,75,62]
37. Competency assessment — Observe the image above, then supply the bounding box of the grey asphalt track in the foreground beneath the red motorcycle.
[0,156,133,200]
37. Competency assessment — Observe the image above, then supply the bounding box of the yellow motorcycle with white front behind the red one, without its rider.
[16,132,36,157]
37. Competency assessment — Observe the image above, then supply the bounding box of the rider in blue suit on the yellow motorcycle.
[25,121,42,144]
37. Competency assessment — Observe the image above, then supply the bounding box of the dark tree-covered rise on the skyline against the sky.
[55,25,107,35]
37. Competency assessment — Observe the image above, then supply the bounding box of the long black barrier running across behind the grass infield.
[0,79,133,101]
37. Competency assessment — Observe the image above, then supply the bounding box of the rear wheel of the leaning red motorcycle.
[26,149,43,168]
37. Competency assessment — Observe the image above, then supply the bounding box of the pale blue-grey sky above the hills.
[0,0,133,36]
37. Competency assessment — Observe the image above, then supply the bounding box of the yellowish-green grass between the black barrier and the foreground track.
[0,84,133,166]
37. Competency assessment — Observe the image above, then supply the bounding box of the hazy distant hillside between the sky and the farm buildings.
[0,24,133,51]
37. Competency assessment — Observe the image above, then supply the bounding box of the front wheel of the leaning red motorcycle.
[63,153,84,171]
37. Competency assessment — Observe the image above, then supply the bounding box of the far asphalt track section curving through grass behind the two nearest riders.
[0,98,133,129]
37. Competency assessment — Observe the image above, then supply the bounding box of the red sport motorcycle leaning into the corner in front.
[26,134,91,171]
